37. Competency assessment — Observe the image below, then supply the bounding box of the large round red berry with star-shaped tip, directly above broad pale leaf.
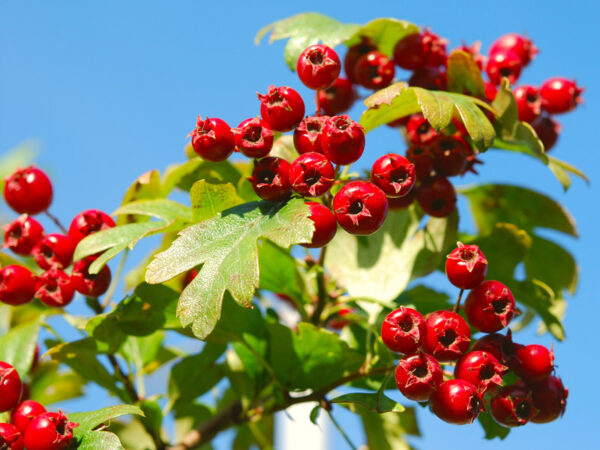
[333,181,388,235]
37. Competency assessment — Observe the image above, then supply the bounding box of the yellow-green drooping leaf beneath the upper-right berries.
[360,83,495,148]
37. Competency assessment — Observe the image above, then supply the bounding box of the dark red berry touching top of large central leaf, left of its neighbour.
[249,156,292,202]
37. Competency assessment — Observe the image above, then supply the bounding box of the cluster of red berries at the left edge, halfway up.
[0,167,115,307]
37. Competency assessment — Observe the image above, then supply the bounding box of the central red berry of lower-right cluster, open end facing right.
[454,350,508,394]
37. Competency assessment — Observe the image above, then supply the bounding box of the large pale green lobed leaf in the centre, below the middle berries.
[146,199,314,339]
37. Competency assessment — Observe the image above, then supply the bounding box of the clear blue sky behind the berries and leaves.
[0,0,600,449]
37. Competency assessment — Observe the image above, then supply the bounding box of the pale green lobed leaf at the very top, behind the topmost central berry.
[254,13,360,70]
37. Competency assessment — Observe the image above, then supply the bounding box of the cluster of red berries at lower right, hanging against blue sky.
[381,243,568,427]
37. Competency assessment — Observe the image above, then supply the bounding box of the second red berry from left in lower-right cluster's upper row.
[424,311,471,362]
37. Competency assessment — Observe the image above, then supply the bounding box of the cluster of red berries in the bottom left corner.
[0,361,78,450]
